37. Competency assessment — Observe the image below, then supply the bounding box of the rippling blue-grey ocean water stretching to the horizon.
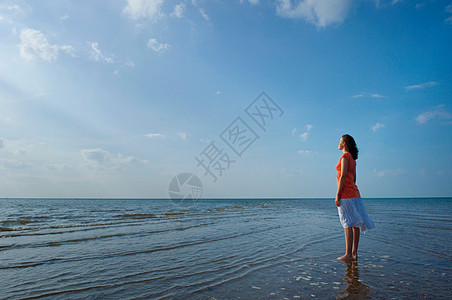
[0,198,452,299]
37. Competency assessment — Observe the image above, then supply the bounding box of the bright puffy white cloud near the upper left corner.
[19,28,74,61]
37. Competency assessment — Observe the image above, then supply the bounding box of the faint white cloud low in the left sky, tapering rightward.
[81,148,147,169]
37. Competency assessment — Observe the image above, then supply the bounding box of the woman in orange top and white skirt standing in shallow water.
[335,134,375,261]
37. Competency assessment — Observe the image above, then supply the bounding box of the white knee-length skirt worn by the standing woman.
[337,198,375,233]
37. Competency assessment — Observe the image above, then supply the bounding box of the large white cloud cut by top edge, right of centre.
[276,0,351,27]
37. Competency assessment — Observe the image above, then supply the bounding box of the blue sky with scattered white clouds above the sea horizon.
[0,0,452,197]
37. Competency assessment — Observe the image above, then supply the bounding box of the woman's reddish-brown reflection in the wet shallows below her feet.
[336,261,370,299]
